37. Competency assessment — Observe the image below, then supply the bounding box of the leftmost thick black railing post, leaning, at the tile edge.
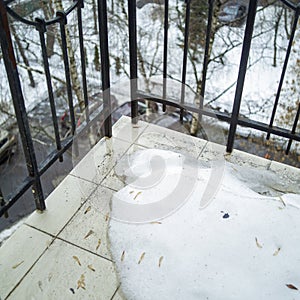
[0,0,46,211]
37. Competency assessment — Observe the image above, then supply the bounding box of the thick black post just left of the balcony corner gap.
[98,0,112,137]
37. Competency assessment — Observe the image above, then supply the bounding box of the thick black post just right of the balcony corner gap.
[128,0,138,124]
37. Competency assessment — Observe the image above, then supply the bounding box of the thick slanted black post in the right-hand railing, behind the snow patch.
[227,0,257,152]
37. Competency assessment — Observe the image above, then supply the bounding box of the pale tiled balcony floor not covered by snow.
[0,117,300,300]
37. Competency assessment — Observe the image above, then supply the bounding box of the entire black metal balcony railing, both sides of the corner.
[0,0,300,216]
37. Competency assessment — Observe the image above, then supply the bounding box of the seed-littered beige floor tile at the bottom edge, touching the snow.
[9,240,118,300]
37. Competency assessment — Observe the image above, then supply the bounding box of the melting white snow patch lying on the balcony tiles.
[109,149,300,300]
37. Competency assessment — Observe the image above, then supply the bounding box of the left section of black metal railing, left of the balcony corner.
[0,0,111,216]
